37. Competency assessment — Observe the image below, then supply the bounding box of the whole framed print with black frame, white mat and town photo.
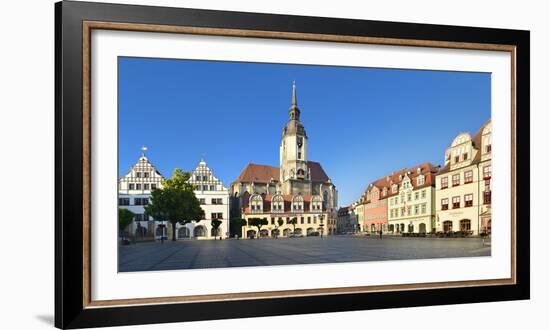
[55,1,529,328]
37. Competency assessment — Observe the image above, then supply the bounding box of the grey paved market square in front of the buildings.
[118,236,491,272]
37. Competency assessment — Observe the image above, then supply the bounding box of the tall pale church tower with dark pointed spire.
[279,82,311,194]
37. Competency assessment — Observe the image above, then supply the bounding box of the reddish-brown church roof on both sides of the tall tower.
[234,161,329,183]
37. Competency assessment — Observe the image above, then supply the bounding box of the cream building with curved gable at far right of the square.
[435,121,492,235]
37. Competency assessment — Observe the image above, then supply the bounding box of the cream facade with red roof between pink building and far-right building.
[387,163,439,234]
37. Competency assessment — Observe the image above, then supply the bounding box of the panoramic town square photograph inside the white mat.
[117,57,492,272]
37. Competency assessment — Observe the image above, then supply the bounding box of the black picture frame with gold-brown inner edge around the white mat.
[55,1,530,328]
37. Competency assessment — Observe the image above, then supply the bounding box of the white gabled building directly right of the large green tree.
[174,160,229,239]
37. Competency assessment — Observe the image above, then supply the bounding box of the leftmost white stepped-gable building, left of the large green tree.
[118,147,163,239]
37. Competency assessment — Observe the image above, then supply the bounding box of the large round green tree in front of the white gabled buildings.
[145,168,204,241]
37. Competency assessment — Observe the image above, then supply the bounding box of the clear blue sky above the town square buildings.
[119,57,491,205]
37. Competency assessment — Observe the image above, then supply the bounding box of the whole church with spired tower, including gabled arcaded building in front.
[231,85,338,237]
